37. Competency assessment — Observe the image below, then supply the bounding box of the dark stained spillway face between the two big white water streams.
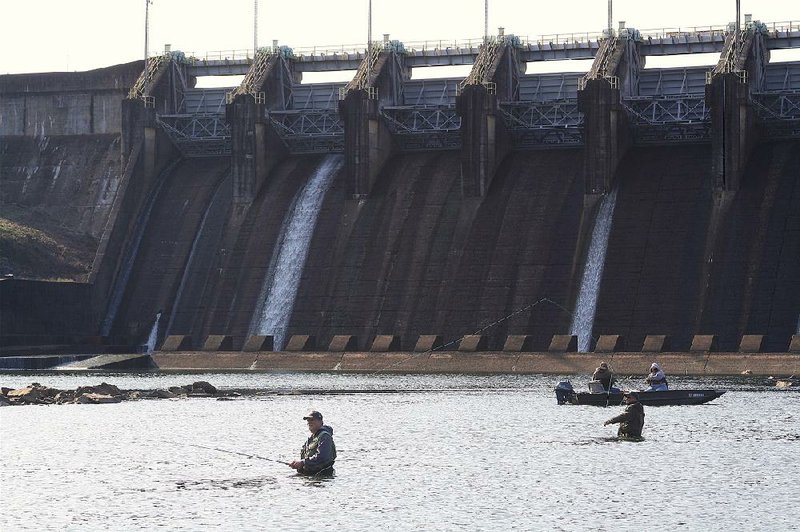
[290,150,583,349]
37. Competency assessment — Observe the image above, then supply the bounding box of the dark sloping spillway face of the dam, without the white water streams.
[123,142,800,351]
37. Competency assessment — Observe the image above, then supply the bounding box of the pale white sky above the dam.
[0,0,800,74]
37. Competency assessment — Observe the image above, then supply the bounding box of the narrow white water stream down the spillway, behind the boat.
[570,189,617,352]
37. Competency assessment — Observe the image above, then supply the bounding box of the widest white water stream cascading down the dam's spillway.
[250,155,343,351]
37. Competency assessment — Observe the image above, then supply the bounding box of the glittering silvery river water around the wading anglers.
[0,373,800,530]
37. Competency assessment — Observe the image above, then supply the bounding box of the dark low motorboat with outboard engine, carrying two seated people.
[556,381,725,406]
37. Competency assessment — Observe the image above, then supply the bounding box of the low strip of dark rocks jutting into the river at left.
[0,381,233,406]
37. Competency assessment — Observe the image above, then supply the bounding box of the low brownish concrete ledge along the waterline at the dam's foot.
[151,351,800,378]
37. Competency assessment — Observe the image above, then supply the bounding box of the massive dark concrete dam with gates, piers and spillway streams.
[0,21,800,362]
